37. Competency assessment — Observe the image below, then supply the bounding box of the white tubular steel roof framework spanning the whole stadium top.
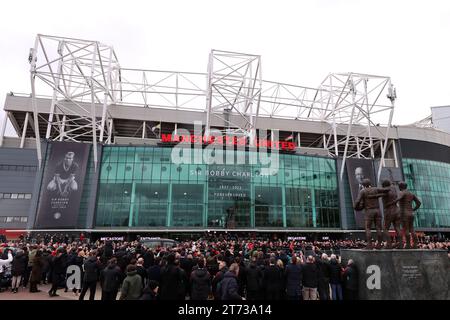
[24,34,396,178]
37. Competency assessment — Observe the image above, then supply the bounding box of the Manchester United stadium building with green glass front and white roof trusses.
[0,35,450,237]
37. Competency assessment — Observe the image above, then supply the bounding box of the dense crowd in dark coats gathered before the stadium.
[0,237,450,300]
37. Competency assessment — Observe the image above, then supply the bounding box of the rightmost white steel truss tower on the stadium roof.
[316,73,397,181]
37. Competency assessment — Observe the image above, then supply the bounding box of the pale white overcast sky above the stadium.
[0,0,450,134]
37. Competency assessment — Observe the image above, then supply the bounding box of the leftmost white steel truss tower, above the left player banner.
[29,34,120,167]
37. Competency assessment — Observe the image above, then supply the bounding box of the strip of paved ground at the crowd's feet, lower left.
[0,284,110,300]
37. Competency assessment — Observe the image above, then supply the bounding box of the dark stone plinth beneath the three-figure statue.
[341,249,450,300]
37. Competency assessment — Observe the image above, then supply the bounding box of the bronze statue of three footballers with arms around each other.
[354,179,421,249]
